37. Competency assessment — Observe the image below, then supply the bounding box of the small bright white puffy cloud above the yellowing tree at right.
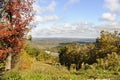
[101,13,116,21]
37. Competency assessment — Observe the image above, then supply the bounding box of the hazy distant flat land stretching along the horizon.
[28,37,96,49]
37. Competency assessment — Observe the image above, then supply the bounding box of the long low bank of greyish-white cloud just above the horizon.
[30,22,96,38]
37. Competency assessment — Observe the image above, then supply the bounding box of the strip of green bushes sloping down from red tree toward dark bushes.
[24,44,58,64]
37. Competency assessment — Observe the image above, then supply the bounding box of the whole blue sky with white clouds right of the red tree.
[29,0,120,38]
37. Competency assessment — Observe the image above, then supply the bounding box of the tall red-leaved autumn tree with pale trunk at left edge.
[0,0,34,70]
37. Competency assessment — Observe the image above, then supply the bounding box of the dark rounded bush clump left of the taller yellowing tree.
[59,44,95,70]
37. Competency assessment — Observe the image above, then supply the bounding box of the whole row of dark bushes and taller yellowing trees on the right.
[59,31,120,71]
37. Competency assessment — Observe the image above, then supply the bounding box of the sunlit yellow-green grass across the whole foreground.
[2,62,120,80]
